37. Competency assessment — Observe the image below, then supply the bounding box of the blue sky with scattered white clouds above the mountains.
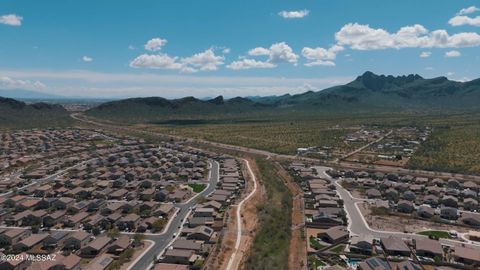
[0,0,480,98]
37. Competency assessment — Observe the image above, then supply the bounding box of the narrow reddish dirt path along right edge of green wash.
[275,162,307,270]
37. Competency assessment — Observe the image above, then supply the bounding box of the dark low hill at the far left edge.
[0,97,71,129]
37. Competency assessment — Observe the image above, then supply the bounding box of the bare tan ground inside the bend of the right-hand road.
[358,203,469,233]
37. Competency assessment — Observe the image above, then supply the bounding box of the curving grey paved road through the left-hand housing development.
[129,161,220,270]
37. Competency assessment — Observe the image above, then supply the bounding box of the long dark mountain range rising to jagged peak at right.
[87,72,480,122]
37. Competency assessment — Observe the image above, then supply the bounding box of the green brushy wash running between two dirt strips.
[244,158,292,270]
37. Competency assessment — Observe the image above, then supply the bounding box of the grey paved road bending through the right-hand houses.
[314,166,480,249]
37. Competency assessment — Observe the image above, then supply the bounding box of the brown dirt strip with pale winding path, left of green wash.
[210,160,262,270]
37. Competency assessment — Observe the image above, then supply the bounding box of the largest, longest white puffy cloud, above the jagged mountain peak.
[335,23,480,50]
